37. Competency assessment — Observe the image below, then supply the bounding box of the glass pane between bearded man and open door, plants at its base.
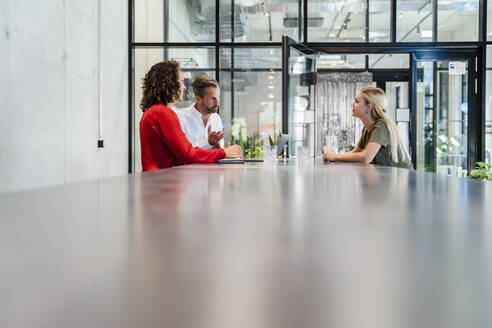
[219,47,282,158]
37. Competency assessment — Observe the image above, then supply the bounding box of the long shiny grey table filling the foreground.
[0,160,492,328]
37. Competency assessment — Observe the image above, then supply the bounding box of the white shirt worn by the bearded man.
[175,104,224,149]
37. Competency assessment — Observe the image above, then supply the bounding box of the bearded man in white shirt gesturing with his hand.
[176,75,224,149]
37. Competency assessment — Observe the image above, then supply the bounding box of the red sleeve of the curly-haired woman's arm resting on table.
[154,108,226,164]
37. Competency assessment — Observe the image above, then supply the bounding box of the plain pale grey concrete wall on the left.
[0,0,128,192]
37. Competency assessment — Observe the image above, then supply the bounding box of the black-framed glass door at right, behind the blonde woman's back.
[412,52,478,177]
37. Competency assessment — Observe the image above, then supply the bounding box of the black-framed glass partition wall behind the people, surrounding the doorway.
[128,0,492,172]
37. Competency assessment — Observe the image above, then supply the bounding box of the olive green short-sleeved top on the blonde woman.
[357,118,413,169]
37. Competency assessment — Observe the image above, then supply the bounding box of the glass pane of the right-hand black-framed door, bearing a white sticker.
[416,61,468,177]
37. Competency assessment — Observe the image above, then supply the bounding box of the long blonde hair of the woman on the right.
[360,88,410,163]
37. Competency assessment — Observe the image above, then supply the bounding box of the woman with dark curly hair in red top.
[140,60,242,171]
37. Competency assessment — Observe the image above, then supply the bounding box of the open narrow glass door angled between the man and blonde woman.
[282,36,317,157]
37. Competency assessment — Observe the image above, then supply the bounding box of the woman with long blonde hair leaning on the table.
[323,88,413,169]
